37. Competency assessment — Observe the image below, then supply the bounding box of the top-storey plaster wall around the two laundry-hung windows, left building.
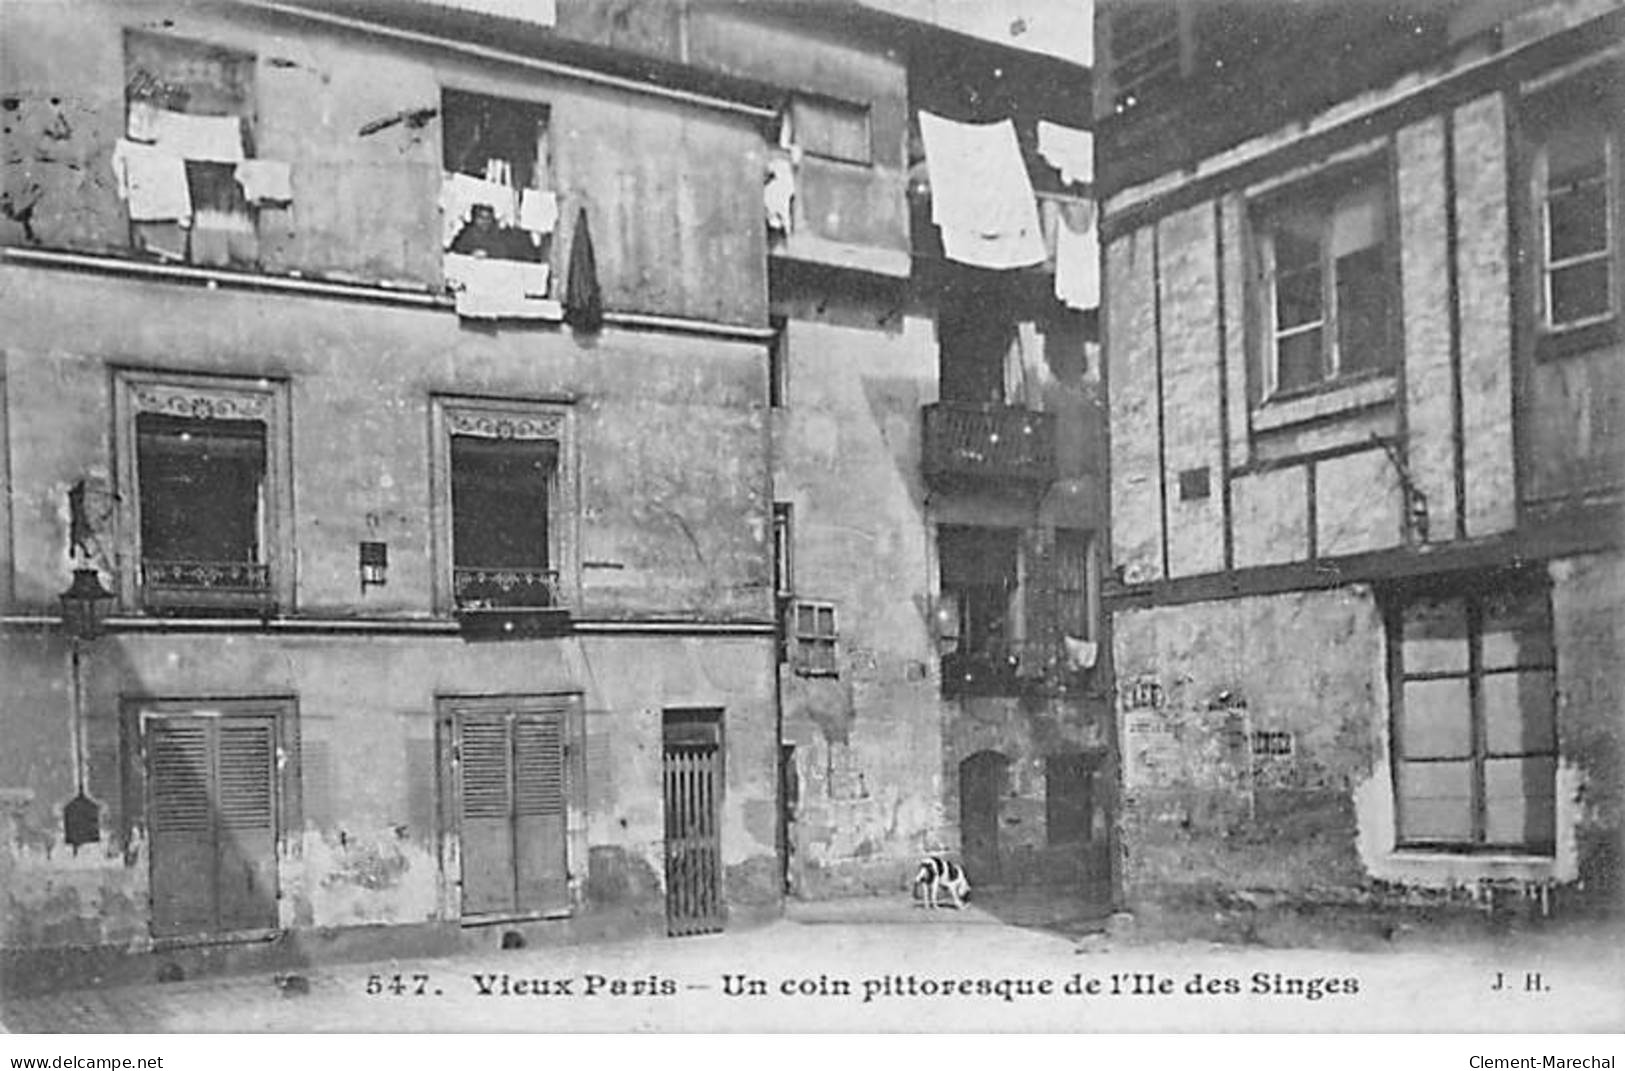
[0,0,767,323]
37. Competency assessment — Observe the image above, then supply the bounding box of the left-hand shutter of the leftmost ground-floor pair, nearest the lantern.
[146,718,216,936]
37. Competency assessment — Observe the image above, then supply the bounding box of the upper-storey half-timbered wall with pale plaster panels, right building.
[1105,94,1560,583]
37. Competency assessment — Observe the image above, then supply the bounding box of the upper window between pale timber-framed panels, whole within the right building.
[1253,163,1399,404]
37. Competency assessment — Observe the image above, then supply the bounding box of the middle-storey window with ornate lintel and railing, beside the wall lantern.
[119,374,291,614]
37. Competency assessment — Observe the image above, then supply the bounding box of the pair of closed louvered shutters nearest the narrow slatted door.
[455,704,569,917]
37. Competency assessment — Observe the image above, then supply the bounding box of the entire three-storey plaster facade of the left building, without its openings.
[0,3,780,951]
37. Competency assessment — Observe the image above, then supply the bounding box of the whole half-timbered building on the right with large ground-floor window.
[1095,0,1625,910]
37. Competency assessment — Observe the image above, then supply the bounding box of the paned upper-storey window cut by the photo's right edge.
[1521,65,1625,356]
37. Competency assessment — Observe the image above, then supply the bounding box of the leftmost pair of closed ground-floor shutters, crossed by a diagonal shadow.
[146,715,278,936]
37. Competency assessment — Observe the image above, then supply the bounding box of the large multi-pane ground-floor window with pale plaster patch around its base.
[1389,574,1557,855]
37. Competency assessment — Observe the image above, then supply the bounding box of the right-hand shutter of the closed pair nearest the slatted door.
[514,713,569,912]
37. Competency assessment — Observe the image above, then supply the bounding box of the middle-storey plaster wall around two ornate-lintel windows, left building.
[0,267,772,621]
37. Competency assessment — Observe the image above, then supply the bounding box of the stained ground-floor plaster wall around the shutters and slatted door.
[0,632,777,947]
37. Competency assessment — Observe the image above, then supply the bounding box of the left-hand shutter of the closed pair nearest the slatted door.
[458,713,515,915]
